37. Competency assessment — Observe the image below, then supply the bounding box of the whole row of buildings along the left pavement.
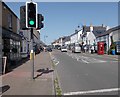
[0,2,40,73]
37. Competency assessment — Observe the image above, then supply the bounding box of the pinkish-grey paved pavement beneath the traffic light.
[1,52,54,95]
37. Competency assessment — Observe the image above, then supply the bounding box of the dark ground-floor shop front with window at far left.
[2,29,21,65]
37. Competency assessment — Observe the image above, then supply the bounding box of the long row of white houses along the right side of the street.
[52,24,120,54]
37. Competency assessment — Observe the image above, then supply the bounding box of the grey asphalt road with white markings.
[52,50,119,95]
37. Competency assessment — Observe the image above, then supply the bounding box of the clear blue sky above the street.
[6,2,118,44]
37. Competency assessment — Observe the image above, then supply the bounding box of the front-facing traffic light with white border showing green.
[26,2,38,28]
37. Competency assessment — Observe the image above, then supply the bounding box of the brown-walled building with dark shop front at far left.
[0,2,21,64]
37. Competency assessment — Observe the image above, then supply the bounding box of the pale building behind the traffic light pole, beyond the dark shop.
[19,30,40,58]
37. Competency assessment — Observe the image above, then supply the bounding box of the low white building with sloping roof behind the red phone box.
[96,26,120,53]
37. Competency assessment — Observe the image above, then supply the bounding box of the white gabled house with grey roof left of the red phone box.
[82,24,108,51]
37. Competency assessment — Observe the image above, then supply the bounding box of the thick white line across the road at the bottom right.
[63,88,120,95]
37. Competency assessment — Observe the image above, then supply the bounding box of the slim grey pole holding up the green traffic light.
[31,28,34,80]
